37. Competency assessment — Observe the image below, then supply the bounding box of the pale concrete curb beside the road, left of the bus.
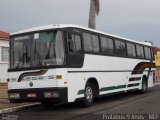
[0,103,41,114]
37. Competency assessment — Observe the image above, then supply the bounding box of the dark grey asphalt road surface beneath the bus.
[0,86,160,120]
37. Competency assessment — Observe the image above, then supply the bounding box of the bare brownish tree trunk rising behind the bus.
[88,0,100,29]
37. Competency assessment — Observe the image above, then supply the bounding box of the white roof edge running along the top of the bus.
[11,24,152,46]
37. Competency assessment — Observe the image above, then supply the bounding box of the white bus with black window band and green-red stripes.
[8,25,155,107]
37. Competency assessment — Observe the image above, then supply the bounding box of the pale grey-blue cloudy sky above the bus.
[0,0,160,47]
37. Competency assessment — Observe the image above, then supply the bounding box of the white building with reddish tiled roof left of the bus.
[0,31,9,82]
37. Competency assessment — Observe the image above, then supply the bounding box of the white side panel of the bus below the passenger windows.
[67,54,153,102]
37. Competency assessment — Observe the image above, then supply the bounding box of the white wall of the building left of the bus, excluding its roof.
[0,40,9,82]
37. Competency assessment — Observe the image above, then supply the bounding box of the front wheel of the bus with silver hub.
[83,82,95,107]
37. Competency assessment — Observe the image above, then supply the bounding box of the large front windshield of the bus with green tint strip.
[10,30,64,69]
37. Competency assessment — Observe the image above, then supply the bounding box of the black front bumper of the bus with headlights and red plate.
[8,87,68,103]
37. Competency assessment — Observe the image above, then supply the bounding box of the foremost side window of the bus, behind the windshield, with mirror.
[67,33,82,53]
